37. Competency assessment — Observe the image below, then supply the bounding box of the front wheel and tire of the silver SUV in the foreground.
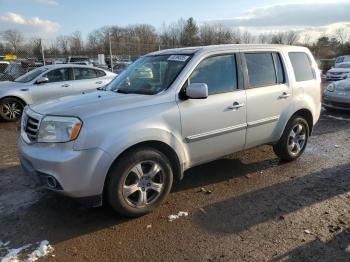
[106,148,173,217]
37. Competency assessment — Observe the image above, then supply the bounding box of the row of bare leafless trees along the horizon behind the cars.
[0,18,350,58]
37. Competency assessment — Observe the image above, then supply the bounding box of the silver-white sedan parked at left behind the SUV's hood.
[0,64,117,121]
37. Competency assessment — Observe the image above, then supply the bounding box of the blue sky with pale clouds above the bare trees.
[0,0,350,41]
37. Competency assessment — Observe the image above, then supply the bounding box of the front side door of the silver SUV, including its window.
[179,54,246,166]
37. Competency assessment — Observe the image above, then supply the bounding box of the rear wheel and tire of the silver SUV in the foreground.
[273,116,310,161]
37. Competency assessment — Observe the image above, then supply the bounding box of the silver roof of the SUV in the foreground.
[151,44,305,55]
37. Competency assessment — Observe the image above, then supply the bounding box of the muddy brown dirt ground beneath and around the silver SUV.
[0,107,350,261]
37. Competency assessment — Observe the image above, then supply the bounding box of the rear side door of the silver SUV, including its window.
[242,51,292,148]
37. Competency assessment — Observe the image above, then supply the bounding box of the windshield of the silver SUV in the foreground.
[107,55,191,95]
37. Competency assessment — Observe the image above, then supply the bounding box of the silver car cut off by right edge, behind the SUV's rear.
[323,79,350,111]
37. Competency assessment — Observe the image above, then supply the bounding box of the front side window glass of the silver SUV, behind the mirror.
[189,55,237,95]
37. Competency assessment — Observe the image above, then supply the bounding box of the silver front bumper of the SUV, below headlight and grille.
[19,138,112,198]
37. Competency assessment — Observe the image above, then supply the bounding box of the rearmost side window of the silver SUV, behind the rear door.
[288,52,315,82]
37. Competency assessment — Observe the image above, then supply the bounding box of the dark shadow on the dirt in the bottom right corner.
[269,229,350,262]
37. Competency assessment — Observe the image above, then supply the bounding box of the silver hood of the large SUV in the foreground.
[30,91,161,118]
